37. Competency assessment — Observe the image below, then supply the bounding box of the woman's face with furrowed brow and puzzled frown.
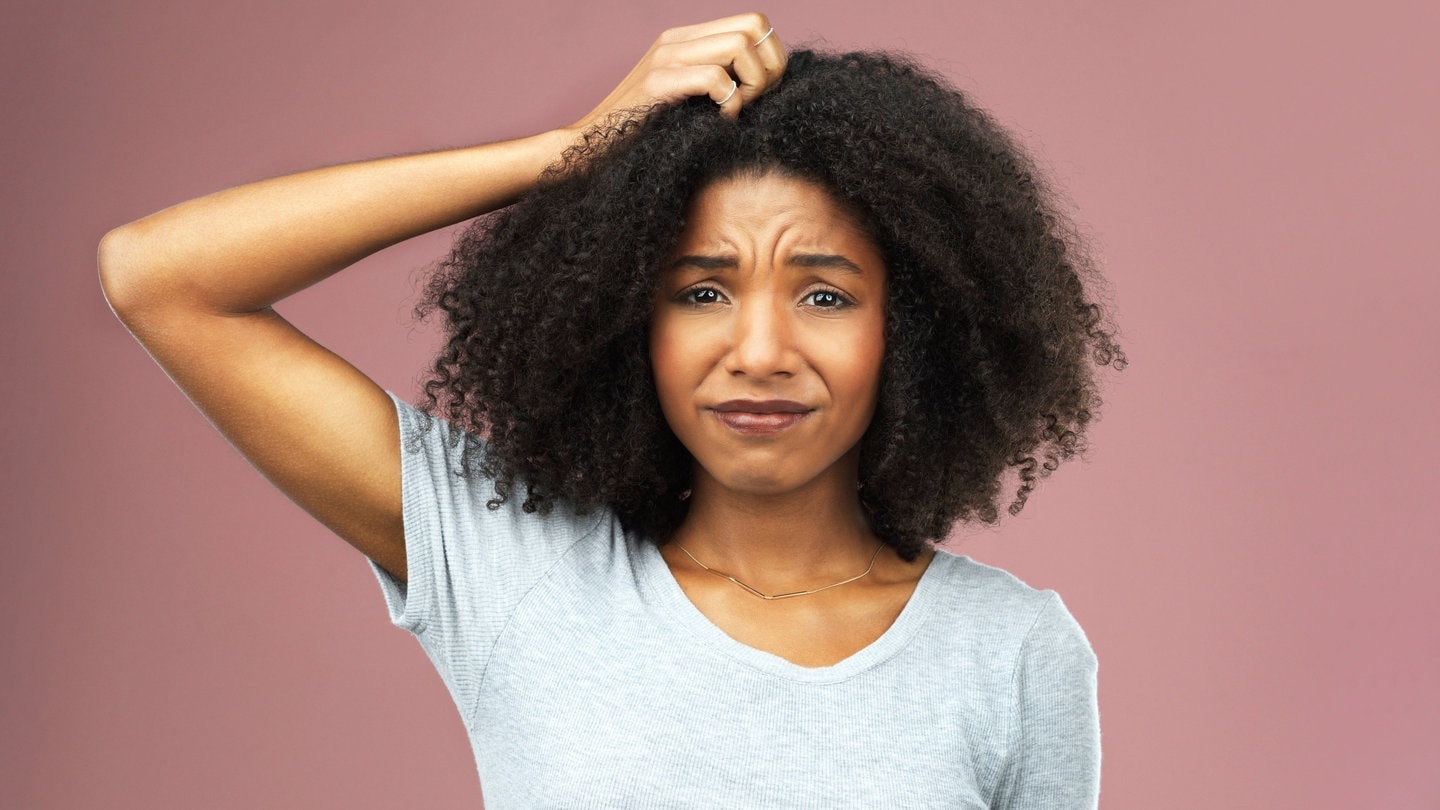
[649,173,886,494]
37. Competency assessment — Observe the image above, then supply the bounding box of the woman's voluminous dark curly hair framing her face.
[419,50,1125,561]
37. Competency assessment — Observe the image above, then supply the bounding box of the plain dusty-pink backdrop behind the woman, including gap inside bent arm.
[0,0,1440,810]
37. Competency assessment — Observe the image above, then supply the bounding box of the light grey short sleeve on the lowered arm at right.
[992,591,1100,810]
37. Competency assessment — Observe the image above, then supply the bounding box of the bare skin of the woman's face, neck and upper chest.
[651,173,933,666]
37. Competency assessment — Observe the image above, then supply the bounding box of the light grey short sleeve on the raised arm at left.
[370,393,598,724]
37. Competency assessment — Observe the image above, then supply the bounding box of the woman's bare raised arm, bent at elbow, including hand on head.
[99,14,785,581]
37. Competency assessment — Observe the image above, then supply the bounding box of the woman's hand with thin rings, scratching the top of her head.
[575,13,786,131]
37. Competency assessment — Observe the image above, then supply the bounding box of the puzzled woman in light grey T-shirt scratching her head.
[101,14,1123,809]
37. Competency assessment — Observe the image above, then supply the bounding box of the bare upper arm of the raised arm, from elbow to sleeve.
[101,227,406,581]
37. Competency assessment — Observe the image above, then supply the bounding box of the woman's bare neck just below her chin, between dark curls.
[674,455,884,592]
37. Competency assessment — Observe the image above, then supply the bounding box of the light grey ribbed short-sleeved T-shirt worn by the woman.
[365,395,1100,810]
